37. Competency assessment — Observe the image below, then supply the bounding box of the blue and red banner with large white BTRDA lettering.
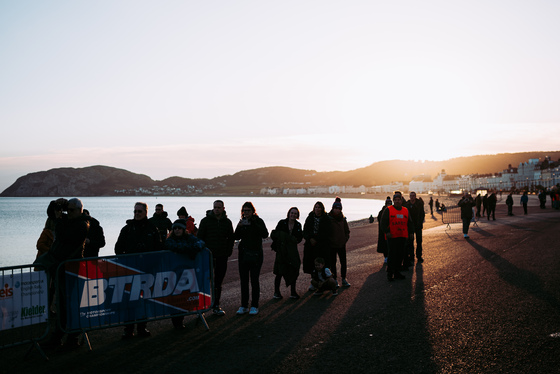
[65,250,212,330]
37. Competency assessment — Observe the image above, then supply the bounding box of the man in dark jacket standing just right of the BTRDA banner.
[198,200,235,316]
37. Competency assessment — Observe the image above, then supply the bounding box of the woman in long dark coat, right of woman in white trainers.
[270,207,303,300]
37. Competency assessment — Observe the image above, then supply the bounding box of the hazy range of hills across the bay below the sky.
[0,151,560,197]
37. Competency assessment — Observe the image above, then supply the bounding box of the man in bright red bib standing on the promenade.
[381,194,414,281]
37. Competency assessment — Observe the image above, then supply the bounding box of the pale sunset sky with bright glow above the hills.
[0,0,560,191]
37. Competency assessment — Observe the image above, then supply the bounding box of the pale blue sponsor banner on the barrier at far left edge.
[0,268,49,331]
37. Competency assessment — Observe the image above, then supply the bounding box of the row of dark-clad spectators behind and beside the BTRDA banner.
[35,197,350,348]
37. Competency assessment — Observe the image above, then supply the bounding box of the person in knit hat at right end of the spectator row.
[328,196,350,287]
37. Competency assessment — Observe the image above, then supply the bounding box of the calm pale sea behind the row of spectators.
[0,196,383,267]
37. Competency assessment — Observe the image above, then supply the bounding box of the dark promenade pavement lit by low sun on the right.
[0,197,560,374]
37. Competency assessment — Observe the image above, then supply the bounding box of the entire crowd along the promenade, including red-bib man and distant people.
[35,189,560,348]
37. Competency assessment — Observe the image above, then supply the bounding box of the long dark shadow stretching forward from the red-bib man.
[300,264,438,373]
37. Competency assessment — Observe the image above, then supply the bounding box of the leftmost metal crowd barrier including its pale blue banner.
[0,265,50,358]
